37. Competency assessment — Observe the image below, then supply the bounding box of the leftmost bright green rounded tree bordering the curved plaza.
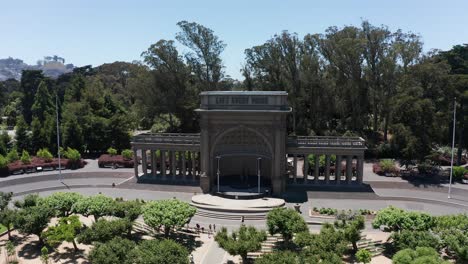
[39,192,83,217]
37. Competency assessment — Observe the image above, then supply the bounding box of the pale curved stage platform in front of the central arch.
[192,194,285,213]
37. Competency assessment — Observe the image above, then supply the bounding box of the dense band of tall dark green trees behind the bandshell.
[0,21,468,164]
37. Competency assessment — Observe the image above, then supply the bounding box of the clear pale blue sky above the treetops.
[0,0,468,78]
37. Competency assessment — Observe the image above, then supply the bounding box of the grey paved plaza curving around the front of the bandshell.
[0,160,468,263]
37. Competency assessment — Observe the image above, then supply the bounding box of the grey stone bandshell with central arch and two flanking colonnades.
[132,91,366,194]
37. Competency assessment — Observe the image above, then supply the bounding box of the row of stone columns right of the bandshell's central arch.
[289,154,364,185]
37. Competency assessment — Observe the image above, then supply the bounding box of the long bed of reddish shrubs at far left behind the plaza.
[0,157,86,176]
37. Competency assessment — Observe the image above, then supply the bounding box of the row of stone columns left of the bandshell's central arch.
[133,149,200,181]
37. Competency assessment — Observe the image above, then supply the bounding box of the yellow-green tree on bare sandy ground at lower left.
[42,215,81,251]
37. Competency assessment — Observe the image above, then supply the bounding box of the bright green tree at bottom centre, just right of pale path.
[215,225,266,263]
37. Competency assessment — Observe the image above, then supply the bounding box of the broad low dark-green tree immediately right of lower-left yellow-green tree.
[78,219,132,244]
